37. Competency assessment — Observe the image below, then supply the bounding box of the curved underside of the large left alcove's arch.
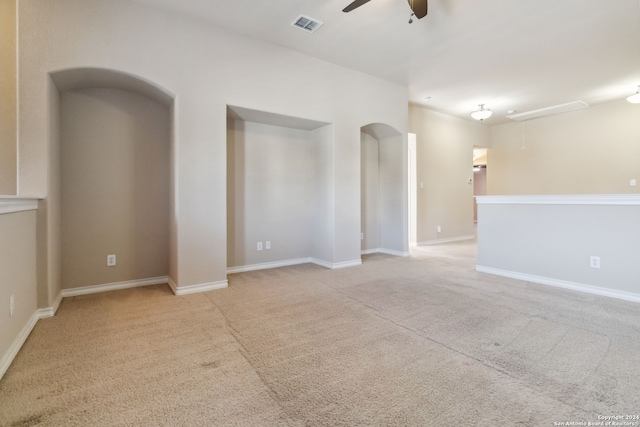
[49,67,176,107]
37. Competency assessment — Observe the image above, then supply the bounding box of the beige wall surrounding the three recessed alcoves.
[19,0,407,300]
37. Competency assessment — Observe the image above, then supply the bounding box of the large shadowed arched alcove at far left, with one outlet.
[45,68,175,295]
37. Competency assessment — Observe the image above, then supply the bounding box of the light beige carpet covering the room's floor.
[0,243,640,426]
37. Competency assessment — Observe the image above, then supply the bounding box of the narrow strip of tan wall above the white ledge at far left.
[0,0,17,194]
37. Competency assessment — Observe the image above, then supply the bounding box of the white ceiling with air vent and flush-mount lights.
[132,0,640,125]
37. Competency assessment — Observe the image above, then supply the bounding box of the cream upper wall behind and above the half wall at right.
[487,100,640,195]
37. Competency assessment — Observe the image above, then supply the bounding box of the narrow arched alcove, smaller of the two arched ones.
[360,123,408,256]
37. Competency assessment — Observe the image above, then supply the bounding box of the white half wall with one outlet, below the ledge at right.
[477,200,640,301]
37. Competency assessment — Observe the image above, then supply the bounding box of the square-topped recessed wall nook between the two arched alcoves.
[227,106,336,273]
